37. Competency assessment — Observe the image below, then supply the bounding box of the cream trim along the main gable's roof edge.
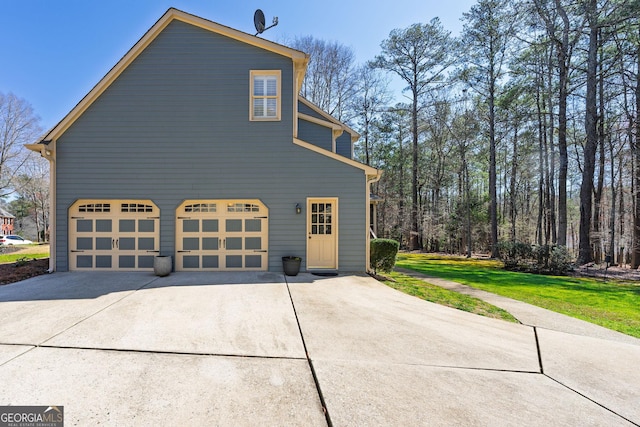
[35,8,309,144]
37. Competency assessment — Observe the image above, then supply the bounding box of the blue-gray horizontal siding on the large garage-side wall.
[56,21,367,271]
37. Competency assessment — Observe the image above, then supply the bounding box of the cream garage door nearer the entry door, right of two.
[176,200,269,271]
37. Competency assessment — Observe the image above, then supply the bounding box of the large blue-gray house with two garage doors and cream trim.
[27,9,380,271]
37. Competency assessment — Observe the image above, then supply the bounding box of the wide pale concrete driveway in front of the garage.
[0,273,640,426]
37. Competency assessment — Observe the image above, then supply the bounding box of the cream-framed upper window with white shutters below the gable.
[249,70,281,120]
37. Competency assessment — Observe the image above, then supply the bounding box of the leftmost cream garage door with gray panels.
[69,200,160,271]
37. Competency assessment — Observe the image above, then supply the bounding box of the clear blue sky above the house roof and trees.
[0,0,475,128]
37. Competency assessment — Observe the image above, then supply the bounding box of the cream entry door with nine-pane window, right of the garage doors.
[307,198,338,269]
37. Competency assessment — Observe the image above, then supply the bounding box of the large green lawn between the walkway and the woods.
[396,254,640,338]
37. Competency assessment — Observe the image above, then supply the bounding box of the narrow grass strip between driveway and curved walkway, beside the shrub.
[384,272,518,322]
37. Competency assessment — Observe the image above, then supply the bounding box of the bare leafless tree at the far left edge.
[0,92,41,198]
